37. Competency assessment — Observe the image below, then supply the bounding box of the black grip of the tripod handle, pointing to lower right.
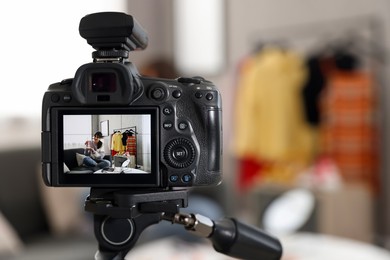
[209,218,283,260]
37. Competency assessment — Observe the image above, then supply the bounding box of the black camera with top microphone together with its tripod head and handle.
[42,12,282,260]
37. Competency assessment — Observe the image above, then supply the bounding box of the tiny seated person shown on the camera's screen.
[83,132,111,169]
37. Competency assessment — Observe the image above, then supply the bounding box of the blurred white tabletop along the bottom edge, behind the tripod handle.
[122,233,390,260]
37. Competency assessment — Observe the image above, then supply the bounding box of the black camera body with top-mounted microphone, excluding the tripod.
[42,12,222,189]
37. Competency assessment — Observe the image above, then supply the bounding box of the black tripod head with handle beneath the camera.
[85,188,282,260]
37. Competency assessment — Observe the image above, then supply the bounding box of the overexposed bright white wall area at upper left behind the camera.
[0,0,126,119]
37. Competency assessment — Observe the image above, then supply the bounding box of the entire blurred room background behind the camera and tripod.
[0,0,390,260]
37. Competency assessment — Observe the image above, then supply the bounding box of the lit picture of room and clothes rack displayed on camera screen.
[63,113,152,175]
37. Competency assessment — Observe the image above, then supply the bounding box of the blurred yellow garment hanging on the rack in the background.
[234,48,314,162]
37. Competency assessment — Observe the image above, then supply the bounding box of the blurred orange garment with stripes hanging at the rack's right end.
[320,69,379,193]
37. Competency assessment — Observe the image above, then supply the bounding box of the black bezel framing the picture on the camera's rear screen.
[52,107,161,187]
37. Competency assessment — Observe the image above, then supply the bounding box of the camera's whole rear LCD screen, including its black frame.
[57,108,159,186]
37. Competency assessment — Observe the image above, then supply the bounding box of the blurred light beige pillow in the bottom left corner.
[0,212,23,258]
